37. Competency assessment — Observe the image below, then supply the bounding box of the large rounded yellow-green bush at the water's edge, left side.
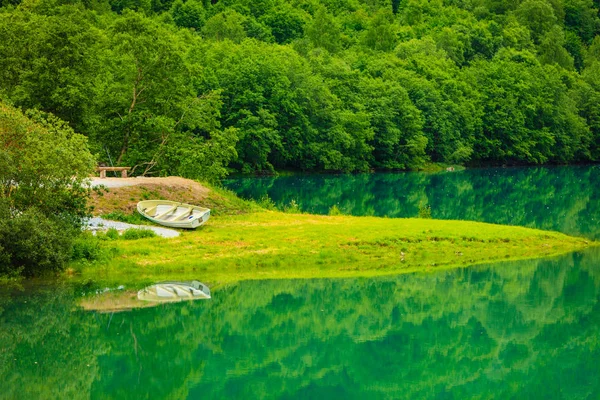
[0,103,94,275]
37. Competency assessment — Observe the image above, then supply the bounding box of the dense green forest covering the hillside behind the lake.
[0,0,600,175]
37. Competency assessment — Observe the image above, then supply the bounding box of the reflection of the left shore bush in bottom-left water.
[0,285,109,399]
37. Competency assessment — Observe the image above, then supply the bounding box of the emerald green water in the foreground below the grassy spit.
[0,249,600,399]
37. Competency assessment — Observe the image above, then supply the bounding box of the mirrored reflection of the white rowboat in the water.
[138,281,210,302]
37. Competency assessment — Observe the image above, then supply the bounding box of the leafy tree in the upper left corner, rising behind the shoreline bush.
[0,6,103,129]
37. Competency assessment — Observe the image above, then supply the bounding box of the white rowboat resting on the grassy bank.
[137,200,210,229]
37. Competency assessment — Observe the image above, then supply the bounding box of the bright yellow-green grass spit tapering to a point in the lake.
[76,211,596,286]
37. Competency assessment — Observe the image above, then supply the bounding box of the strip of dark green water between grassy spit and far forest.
[224,166,600,239]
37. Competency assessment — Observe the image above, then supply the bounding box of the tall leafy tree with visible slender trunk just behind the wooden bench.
[88,13,215,173]
